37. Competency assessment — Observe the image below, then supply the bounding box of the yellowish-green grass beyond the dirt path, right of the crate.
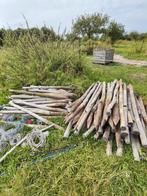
[114,40,147,60]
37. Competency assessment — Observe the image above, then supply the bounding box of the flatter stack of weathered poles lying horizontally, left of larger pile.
[0,86,75,130]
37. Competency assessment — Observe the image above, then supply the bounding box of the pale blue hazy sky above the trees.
[0,0,147,32]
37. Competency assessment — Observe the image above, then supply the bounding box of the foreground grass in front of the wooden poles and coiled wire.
[0,120,147,196]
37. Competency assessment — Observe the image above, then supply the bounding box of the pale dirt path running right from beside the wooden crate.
[114,54,147,66]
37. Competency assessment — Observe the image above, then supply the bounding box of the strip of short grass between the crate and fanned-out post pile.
[87,57,147,103]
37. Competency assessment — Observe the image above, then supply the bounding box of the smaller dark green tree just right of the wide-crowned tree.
[106,21,125,44]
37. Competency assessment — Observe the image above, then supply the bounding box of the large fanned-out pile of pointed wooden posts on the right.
[64,80,147,161]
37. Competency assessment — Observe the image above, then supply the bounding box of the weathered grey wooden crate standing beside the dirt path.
[93,48,114,64]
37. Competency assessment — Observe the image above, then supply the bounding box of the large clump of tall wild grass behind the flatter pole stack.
[1,33,84,87]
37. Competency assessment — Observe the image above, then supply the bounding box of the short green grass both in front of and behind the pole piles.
[0,40,147,196]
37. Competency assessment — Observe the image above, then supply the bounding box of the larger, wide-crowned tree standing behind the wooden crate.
[72,13,109,39]
